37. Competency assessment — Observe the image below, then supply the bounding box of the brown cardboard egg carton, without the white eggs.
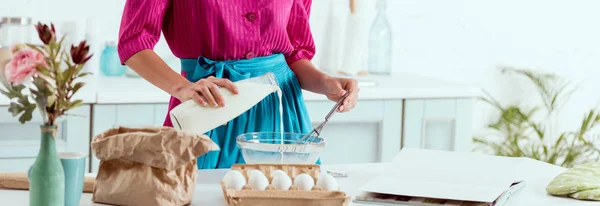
[221,164,350,206]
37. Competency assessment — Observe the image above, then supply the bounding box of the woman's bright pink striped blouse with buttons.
[118,0,315,64]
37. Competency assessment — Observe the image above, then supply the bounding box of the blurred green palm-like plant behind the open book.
[473,68,600,168]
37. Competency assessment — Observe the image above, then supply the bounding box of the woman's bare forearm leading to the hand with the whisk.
[290,59,329,94]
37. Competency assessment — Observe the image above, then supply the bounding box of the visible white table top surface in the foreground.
[0,161,600,206]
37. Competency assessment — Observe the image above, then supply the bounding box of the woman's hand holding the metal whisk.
[323,77,360,112]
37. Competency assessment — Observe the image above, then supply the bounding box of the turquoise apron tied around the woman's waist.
[181,54,320,169]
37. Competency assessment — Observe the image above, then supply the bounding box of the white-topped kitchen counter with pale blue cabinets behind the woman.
[0,71,481,172]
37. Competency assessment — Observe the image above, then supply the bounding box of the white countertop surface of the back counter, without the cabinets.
[0,74,480,105]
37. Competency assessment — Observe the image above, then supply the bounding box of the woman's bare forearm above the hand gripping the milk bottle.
[125,50,190,98]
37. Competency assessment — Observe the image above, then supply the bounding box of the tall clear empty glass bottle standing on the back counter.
[368,0,392,75]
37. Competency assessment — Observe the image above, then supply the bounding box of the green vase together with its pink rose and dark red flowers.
[0,23,92,206]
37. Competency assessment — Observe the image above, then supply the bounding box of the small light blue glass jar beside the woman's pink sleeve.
[100,42,127,77]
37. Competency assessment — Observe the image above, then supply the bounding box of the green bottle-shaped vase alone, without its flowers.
[29,126,65,206]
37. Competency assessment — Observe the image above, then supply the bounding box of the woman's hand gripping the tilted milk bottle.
[177,76,238,107]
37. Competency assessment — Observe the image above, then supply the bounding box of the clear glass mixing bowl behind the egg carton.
[237,132,325,164]
